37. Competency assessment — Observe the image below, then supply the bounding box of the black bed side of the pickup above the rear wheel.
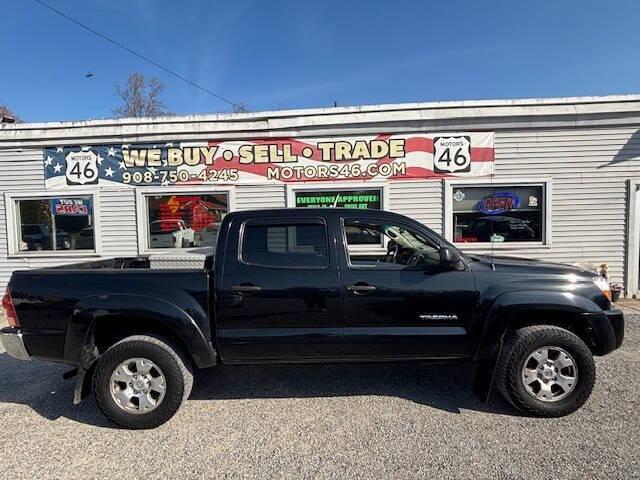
[10,257,212,364]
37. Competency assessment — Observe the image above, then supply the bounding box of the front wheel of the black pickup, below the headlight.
[496,325,596,417]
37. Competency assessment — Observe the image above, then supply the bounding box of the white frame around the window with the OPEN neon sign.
[443,177,553,250]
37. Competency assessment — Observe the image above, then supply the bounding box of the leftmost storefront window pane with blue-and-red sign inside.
[16,197,95,252]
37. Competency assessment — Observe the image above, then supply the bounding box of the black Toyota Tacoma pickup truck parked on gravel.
[1,208,624,428]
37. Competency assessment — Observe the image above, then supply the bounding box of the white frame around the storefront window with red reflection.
[136,185,235,255]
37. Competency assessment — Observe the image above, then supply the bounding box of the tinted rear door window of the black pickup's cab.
[241,220,329,268]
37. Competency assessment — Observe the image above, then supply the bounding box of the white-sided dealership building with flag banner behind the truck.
[0,95,640,296]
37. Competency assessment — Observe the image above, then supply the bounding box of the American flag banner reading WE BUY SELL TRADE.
[43,132,494,188]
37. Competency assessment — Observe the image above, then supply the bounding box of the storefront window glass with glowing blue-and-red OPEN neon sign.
[452,185,545,243]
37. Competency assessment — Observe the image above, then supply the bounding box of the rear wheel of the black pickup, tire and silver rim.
[93,335,193,429]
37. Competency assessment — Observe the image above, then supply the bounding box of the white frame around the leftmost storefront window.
[4,189,102,258]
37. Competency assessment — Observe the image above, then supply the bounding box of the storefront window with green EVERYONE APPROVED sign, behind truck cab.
[295,188,382,245]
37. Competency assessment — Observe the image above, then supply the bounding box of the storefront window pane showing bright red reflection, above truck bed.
[147,194,228,248]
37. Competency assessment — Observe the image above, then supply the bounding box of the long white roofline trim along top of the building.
[0,95,640,149]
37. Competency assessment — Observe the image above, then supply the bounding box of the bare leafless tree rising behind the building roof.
[113,73,171,118]
